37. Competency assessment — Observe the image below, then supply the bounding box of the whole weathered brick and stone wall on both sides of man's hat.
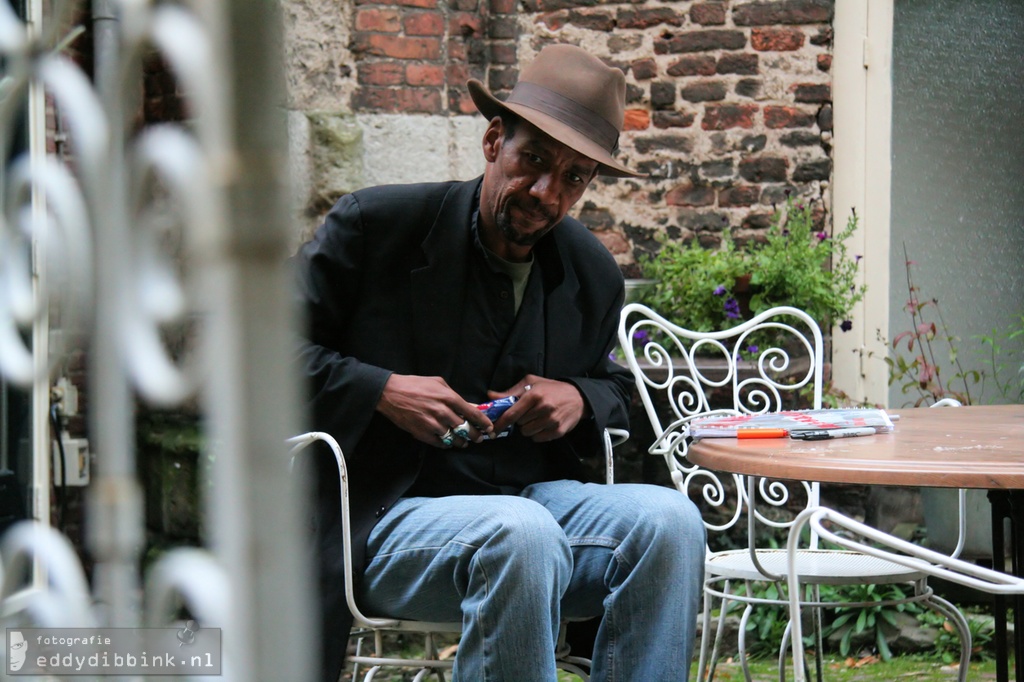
[285,0,834,268]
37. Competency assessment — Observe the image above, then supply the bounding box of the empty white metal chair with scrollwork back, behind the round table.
[618,303,970,681]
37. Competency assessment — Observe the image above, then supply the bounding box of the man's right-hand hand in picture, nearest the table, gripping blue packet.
[487,374,587,442]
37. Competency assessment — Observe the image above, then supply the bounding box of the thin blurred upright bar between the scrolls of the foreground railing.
[88,0,144,628]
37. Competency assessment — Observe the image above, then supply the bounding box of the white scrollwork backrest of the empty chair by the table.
[618,303,823,548]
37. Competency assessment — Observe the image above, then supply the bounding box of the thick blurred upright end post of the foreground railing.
[204,0,318,680]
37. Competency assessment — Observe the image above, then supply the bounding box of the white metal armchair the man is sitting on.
[288,431,598,682]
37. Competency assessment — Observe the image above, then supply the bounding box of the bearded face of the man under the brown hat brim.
[480,119,597,260]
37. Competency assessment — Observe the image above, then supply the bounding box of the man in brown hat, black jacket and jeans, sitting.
[295,45,705,682]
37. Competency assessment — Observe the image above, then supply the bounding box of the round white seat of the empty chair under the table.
[705,549,924,585]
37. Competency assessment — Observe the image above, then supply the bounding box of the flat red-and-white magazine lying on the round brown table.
[690,408,893,438]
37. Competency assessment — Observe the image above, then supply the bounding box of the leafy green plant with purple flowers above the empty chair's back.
[642,200,865,332]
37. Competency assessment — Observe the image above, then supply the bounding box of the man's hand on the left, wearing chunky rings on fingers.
[377,374,494,447]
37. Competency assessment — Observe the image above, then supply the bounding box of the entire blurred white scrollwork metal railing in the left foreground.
[0,0,316,682]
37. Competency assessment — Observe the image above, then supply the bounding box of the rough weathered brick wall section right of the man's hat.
[530,0,833,274]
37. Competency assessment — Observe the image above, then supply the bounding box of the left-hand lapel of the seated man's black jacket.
[410,179,480,376]
